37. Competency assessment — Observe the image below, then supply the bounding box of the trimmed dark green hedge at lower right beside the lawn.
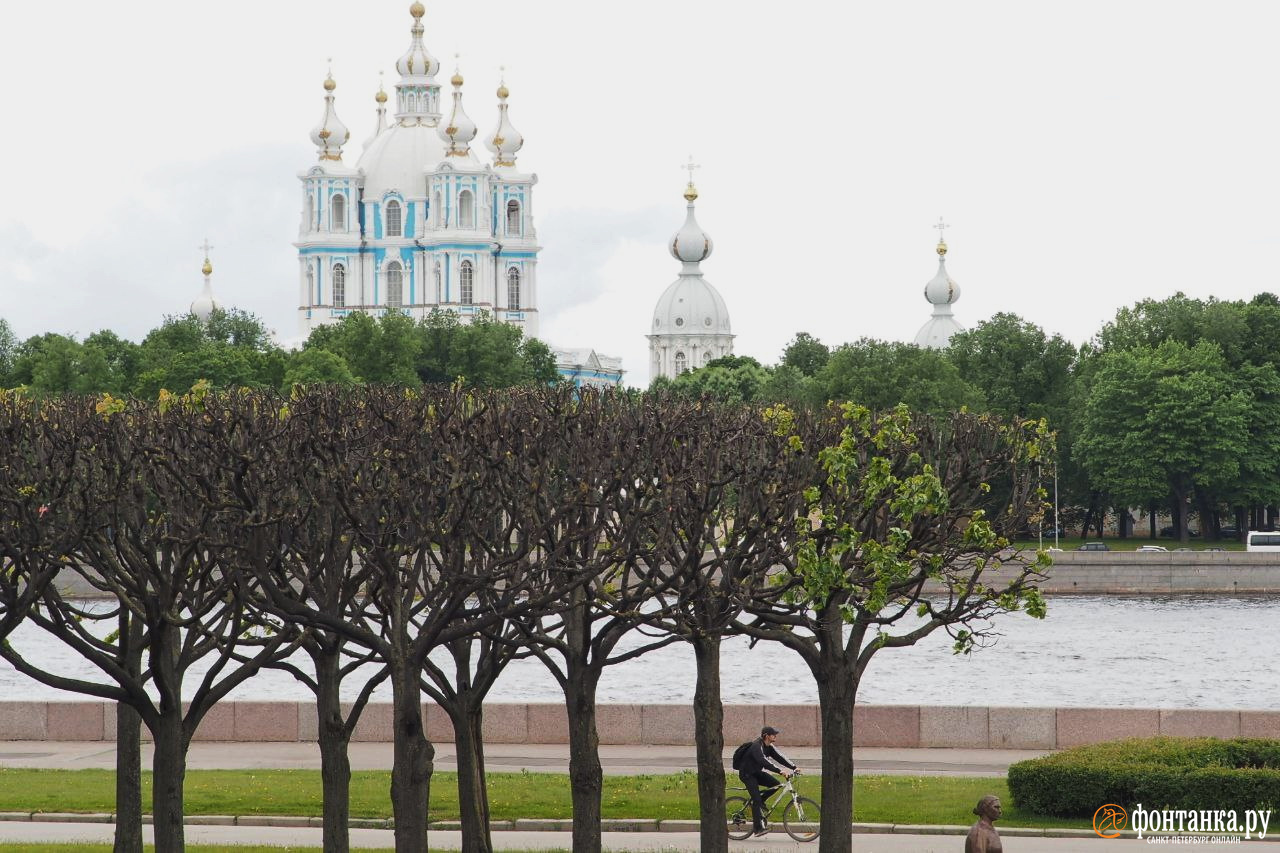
[1009,738,1280,817]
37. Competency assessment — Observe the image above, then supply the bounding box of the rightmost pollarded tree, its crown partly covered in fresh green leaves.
[737,403,1051,853]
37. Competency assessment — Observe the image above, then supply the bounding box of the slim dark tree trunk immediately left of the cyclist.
[692,635,732,853]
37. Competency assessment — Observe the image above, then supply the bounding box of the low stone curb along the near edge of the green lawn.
[0,812,1280,841]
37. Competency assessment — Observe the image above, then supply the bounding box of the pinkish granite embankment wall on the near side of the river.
[0,702,1280,749]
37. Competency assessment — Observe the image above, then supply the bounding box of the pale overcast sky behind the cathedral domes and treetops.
[0,0,1280,384]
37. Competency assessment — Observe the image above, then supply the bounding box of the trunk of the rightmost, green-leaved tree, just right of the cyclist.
[818,667,858,853]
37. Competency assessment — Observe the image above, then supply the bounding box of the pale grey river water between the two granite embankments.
[0,596,1280,708]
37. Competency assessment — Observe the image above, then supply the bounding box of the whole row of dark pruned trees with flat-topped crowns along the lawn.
[0,386,1051,852]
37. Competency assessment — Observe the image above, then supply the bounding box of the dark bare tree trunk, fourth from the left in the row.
[390,661,435,853]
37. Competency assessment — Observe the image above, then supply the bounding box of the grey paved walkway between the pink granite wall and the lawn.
[0,740,1044,776]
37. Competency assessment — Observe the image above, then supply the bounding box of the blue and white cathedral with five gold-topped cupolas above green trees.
[294,3,540,337]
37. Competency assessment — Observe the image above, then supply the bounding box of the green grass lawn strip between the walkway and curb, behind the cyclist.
[0,768,1089,829]
